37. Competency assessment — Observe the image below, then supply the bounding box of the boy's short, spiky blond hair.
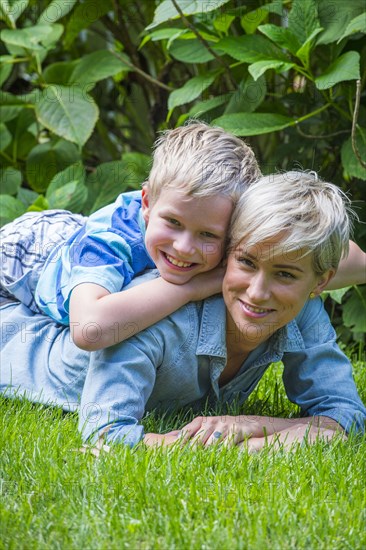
[147,120,261,203]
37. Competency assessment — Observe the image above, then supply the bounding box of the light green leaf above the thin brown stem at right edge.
[315,51,360,90]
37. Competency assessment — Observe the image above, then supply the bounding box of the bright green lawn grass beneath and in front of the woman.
[0,352,366,550]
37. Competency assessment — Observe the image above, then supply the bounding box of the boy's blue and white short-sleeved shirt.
[35,191,155,325]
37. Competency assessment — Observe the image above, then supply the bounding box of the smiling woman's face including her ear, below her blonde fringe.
[223,238,334,350]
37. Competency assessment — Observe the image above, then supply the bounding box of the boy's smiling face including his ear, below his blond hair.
[142,187,233,285]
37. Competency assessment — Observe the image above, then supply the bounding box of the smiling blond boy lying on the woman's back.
[1,122,260,351]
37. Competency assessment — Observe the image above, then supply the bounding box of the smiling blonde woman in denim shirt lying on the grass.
[1,172,366,450]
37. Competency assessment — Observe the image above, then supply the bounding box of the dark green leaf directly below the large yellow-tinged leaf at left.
[26,139,80,193]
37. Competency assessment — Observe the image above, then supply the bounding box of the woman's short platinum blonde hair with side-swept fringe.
[229,171,356,275]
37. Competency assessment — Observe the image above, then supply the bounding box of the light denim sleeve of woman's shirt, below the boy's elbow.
[79,330,163,447]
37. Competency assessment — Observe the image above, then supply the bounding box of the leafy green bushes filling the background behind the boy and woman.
[0,0,366,338]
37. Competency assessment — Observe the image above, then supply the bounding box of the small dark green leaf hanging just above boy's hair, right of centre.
[225,76,267,114]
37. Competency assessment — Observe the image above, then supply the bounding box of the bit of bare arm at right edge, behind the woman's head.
[326,241,366,290]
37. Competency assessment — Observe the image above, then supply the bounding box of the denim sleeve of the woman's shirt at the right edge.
[283,298,366,433]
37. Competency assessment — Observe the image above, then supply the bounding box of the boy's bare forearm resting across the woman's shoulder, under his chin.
[69,268,224,351]
